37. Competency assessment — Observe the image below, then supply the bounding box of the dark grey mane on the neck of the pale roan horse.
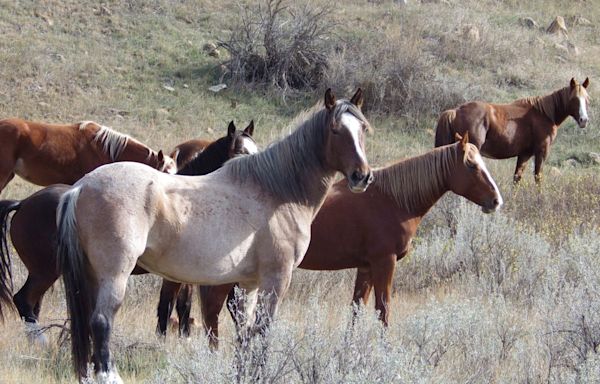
[223,100,369,202]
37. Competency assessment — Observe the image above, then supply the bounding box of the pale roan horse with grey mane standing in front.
[57,89,372,383]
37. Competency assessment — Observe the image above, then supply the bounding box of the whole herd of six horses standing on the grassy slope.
[0,78,589,383]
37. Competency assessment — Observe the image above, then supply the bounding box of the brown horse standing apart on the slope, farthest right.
[435,78,590,183]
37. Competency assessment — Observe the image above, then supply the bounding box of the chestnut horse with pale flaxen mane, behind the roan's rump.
[0,119,177,192]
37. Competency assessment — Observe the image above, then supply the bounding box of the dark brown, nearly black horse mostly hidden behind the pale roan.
[0,122,257,337]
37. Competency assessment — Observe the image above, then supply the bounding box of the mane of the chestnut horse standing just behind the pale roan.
[372,144,458,213]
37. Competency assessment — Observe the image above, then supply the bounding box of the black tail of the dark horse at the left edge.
[0,200,21,320]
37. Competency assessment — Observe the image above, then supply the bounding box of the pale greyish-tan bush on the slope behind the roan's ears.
[327,31,467,123]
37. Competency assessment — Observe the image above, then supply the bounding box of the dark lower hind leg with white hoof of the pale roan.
[90,276,127,384]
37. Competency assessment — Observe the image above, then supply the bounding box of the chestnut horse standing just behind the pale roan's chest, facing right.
[200,134,502,347]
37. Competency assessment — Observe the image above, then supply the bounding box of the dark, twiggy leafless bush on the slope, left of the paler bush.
[221,0,333,92]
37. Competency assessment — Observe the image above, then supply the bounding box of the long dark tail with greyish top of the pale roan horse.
[56,186,93,377]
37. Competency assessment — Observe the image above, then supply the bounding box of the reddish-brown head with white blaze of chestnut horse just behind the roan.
[449,132,503,213]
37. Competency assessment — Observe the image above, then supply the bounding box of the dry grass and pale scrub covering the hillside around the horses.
[0,0,600,383]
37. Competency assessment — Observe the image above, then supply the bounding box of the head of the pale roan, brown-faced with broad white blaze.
[325,88,373,192]
